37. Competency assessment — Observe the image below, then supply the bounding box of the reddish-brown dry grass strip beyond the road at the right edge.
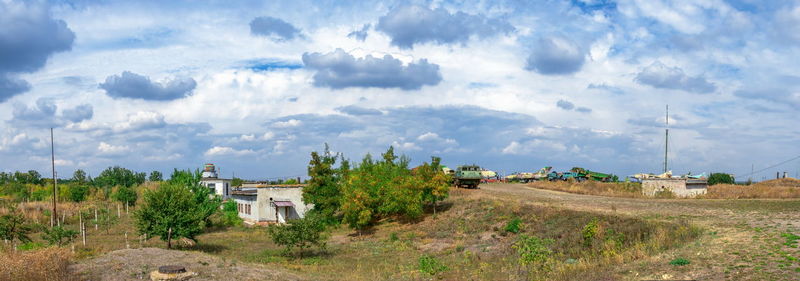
[700,178,800,199]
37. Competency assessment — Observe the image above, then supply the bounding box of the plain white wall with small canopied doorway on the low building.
[257,187,313,222]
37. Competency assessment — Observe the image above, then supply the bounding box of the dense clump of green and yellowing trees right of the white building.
[303,145,449,231]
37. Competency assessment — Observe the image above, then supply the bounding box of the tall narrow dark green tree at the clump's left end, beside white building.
[303,144,344,224]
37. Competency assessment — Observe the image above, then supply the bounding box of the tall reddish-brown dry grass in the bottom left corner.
[0,248,80,281]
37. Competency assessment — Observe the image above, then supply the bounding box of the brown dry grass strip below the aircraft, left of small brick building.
[528,181,645,198]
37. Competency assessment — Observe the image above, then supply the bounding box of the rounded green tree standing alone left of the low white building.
[134,169,220,248]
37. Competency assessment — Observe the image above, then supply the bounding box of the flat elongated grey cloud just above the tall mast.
[635,61,717,94]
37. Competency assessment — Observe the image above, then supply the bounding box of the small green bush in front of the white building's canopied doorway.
[267,214,326,258]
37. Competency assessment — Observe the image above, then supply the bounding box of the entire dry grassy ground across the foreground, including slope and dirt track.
[0,180,800,280]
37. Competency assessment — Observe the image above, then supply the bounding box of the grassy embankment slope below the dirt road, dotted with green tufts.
[188,192,701,280]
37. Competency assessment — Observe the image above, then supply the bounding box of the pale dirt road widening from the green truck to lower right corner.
[476,184,800,280]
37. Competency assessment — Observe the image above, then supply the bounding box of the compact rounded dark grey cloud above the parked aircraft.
[525,37,585,75]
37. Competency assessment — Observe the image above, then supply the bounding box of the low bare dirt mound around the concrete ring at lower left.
[71,248,303,281]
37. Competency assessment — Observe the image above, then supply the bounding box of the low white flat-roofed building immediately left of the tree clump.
[231,184,313,223]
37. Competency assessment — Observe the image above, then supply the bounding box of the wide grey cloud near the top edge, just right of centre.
[375,5,515,49]
